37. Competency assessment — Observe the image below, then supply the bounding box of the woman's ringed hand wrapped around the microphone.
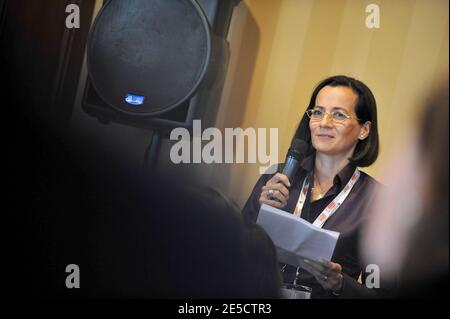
[259,173,291,208]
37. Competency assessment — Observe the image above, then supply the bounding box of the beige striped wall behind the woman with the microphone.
[216,0,448,205]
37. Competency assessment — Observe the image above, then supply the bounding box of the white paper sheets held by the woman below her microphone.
[256,204,339,266]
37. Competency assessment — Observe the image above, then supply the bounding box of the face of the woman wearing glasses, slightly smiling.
[309,86,370,157]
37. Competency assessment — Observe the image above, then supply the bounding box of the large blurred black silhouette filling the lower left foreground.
[3,109,279,298]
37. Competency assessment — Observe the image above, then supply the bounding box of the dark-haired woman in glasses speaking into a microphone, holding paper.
[243,76,379,298]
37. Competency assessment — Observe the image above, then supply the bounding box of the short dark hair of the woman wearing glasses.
[294,75,379,167]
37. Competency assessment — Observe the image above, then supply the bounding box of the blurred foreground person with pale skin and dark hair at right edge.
[362,77,449,298]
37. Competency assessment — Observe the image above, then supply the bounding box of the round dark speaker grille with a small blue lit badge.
[88,0,211,115]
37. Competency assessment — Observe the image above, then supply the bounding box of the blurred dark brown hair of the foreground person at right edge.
[400,79,449,298]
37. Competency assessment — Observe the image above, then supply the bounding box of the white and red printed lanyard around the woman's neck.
[294,168,361,228]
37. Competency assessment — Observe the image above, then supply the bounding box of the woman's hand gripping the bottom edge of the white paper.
[303,259,344,292]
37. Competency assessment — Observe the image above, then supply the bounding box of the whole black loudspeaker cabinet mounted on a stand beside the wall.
[82,0,240,130]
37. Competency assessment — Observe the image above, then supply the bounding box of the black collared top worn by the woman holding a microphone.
[243,154,379,298]
